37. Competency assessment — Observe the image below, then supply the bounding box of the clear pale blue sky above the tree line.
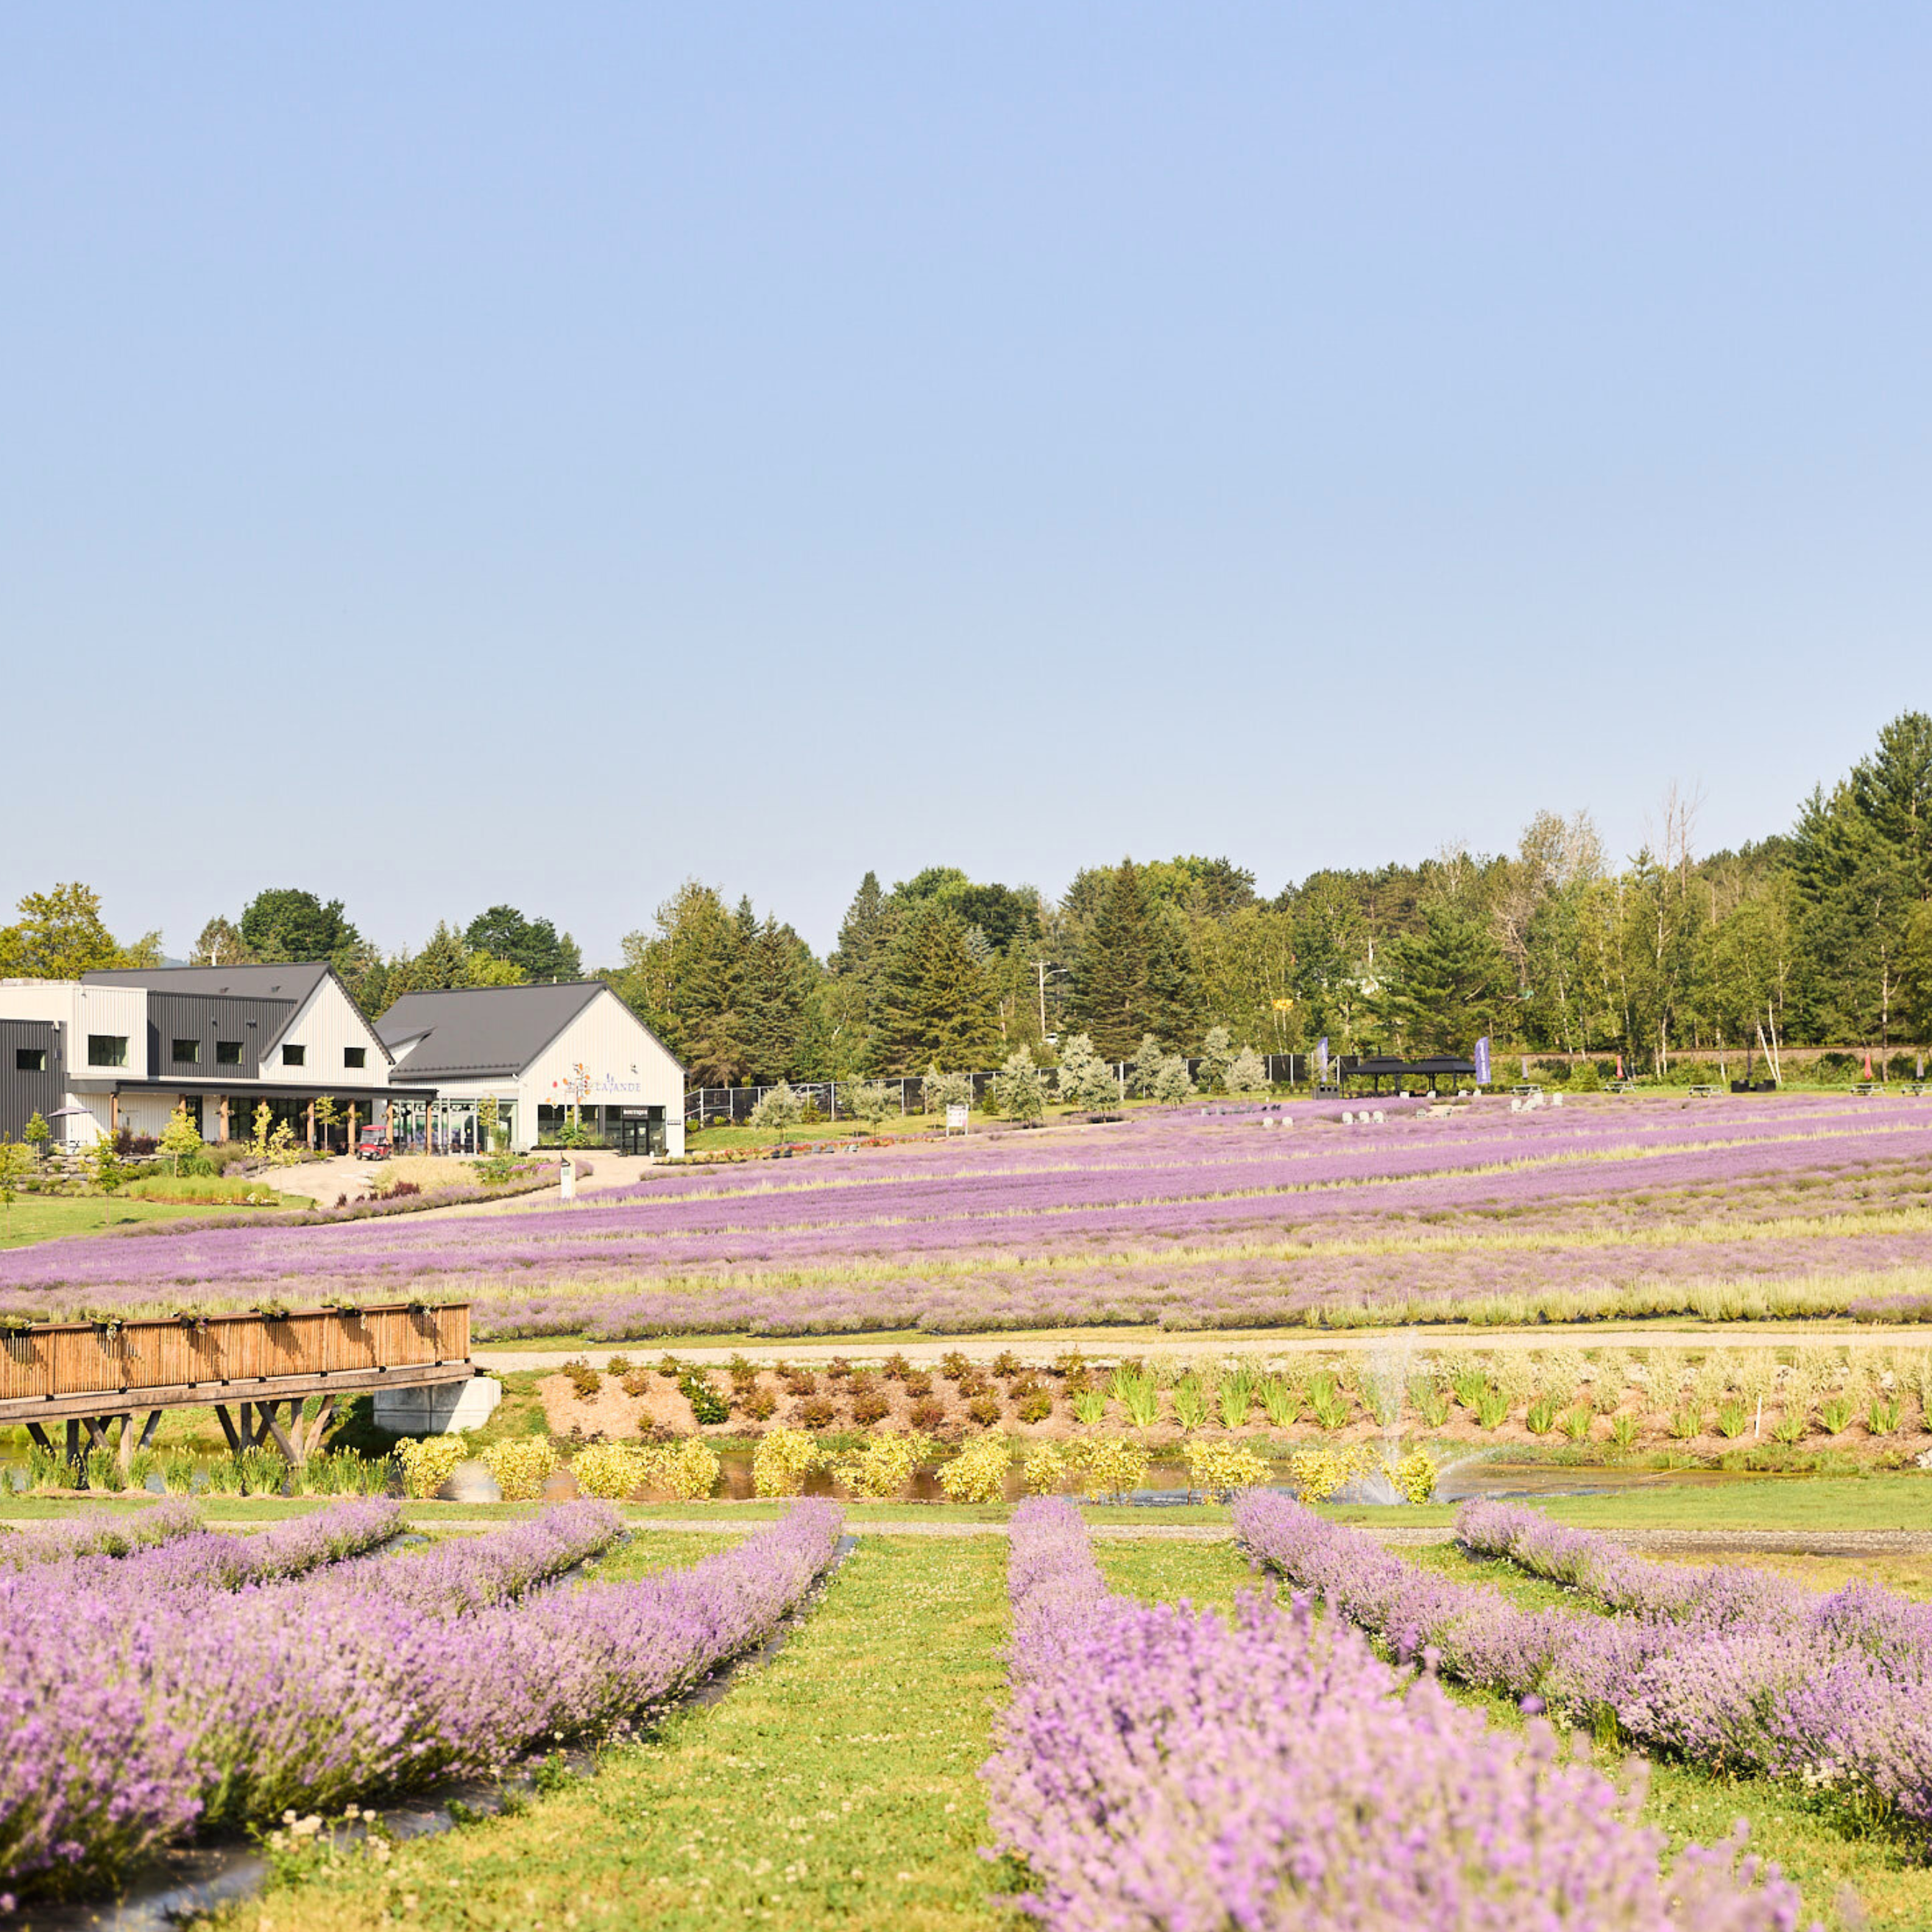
[0,0,1932,958]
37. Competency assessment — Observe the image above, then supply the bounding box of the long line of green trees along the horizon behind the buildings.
[11,711,1932,1086]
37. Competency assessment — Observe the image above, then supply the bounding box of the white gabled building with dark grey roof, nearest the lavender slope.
[375,980,684,1153]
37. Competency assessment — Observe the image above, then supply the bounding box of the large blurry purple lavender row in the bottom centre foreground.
[983,1499,1799,1932]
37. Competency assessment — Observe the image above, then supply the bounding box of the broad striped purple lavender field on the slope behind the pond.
[11,1097,1932,1341]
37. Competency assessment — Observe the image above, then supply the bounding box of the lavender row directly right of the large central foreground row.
[1234,1492,1932,1827]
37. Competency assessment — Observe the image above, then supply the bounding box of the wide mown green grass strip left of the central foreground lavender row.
[224,1536,1013,1932]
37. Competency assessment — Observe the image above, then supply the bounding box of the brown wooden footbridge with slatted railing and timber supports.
[0,1302,481,1468]
